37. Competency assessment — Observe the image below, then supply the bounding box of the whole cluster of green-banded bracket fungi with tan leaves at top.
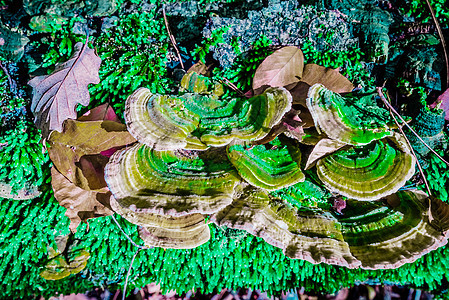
[100,47,447,269]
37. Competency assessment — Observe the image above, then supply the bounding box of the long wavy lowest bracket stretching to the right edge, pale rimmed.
[212,187,447,269]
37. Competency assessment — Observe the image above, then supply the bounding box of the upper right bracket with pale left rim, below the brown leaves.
[306,84,393,145]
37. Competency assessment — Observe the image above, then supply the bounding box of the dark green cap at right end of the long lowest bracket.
[337,191,447,269]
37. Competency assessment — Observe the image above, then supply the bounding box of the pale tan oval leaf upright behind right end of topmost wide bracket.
[253,46,304,94]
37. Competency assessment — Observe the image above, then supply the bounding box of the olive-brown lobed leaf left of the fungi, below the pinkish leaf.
[47,118,136,190]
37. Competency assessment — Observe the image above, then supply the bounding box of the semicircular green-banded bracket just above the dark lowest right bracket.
[316,134,415,201]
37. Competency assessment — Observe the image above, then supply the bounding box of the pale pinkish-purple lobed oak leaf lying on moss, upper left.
[28,42,101,136]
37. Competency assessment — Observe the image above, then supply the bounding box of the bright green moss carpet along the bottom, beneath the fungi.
[0,188,449,298]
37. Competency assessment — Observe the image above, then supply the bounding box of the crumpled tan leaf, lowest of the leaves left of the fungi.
[51,167,114,232]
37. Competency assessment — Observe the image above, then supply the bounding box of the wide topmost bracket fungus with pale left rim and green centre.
[125,88,292,150]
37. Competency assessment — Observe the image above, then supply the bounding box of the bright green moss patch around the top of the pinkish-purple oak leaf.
[34,6,174,121]
